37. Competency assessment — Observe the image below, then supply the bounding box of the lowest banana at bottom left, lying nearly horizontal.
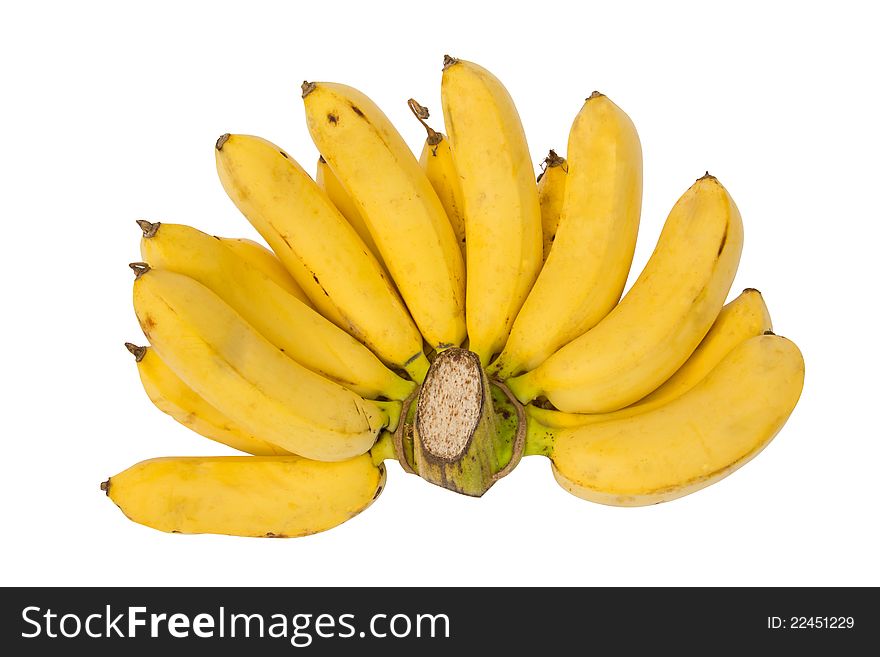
[101,455,385,538]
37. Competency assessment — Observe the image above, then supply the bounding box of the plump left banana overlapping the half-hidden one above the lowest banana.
[132,263,400,461]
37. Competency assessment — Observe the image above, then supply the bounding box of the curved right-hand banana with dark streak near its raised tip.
[507,174,743,413]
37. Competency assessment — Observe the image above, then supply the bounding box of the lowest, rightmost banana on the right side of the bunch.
[529,335,804,506]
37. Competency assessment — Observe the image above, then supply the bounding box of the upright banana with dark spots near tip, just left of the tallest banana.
[303,82,466,350]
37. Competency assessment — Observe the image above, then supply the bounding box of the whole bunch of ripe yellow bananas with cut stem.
[102,57,804,537]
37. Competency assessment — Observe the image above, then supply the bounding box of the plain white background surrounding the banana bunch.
[0,0,880,586]
